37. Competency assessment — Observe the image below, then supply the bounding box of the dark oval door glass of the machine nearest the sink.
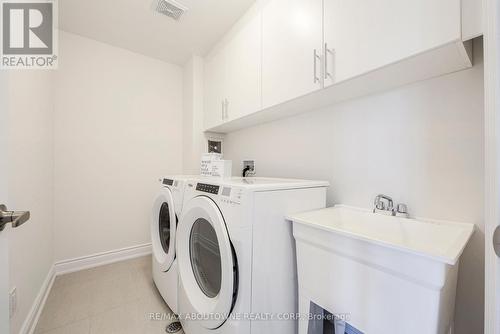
[189,218,222,298]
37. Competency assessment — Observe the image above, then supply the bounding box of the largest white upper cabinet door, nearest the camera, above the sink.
[324,0,461,86]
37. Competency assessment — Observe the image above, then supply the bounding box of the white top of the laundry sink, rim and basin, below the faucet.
[287,205,475,265]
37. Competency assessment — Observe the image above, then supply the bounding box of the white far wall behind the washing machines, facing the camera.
[54,32,183,261]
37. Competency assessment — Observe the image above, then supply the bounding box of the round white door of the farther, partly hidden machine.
[151,187,177,271]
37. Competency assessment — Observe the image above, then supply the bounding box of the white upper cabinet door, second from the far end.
[226,14,262,121]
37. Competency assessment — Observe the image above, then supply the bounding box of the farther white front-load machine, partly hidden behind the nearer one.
[151,176,192,314]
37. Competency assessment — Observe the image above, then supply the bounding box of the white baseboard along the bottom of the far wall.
[54,243,151,276]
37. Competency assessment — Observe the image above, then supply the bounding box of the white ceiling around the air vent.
[59,0,255,65]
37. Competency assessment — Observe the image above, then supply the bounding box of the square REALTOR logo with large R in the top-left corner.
[0,0,58,69]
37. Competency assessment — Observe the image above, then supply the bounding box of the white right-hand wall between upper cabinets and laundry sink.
[224,40,484,334]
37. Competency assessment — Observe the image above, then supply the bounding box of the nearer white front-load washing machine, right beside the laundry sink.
[177,178,328,334]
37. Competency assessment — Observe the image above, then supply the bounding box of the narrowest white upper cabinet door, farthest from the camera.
[204,48,226,129]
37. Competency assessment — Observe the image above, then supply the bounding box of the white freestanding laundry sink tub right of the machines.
[288,206,474,334]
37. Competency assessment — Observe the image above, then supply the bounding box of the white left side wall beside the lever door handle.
[8,71,53,333]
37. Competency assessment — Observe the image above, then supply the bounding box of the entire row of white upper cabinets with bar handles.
[205,0,476,132]
